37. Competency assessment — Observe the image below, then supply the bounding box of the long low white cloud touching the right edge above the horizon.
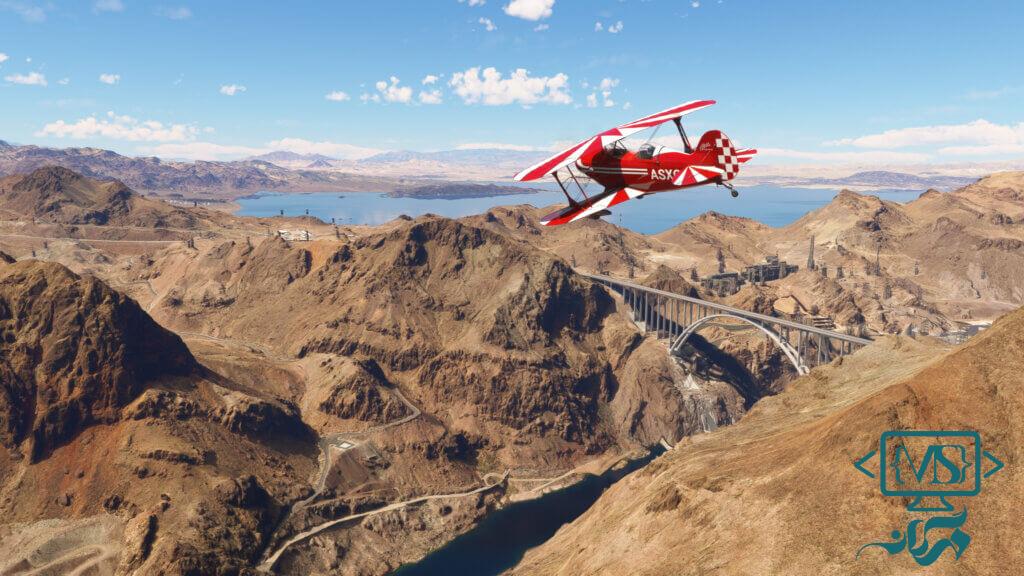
[825,120,1024,150]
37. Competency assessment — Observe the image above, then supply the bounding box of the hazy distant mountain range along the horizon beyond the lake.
[0,140,991,200]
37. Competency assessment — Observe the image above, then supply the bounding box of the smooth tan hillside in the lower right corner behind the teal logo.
[513,303,1024,575]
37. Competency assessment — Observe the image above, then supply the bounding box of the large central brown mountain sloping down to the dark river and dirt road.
[83,216,743,574]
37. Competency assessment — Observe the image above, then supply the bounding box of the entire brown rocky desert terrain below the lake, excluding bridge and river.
[0,163,1024,575]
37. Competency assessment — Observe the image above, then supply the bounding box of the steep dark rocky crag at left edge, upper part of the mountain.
[0,260,197,460]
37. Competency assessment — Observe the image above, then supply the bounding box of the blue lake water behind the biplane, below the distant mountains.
[238,186,921,234]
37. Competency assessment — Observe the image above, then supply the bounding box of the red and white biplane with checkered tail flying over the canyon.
[515,100,758,225]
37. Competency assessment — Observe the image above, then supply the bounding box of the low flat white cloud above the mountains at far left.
[36,112,200,141]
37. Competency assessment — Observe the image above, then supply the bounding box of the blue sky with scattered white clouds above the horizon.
[0,0,1024,164]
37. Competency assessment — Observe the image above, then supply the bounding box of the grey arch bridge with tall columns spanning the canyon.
[582,274,871,374]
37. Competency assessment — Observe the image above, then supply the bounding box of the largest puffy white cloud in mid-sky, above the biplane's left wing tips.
[449,67,572,106]
